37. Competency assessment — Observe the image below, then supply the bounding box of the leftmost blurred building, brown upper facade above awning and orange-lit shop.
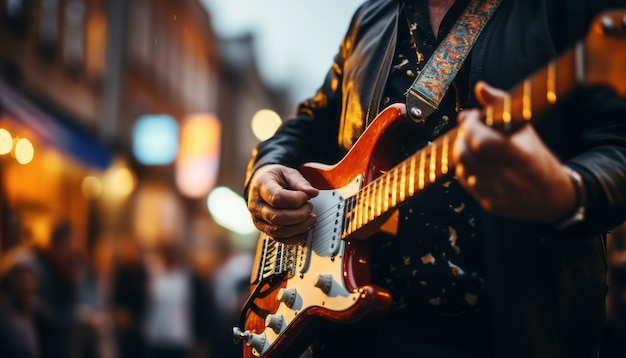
[0,0,115,255]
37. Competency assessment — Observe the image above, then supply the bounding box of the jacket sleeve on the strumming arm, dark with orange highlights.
[244,6,363,198]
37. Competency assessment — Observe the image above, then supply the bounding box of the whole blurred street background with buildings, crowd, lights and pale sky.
[0,0,626,358]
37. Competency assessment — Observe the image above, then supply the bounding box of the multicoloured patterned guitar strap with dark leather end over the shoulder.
[406,0,501,123]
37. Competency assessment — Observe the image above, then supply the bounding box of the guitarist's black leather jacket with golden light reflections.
[246,0,626,358]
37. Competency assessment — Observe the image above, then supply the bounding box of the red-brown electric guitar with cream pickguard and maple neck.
[233,11,626,358]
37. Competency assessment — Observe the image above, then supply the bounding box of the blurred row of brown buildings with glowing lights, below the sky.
[0,0,286,272]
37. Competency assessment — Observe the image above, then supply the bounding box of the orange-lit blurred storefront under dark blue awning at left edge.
[0,82,112,252]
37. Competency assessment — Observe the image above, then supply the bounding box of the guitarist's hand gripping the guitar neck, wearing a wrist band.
[452,82,576,223]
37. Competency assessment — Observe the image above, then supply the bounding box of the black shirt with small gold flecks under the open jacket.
[373,1,484,315]
